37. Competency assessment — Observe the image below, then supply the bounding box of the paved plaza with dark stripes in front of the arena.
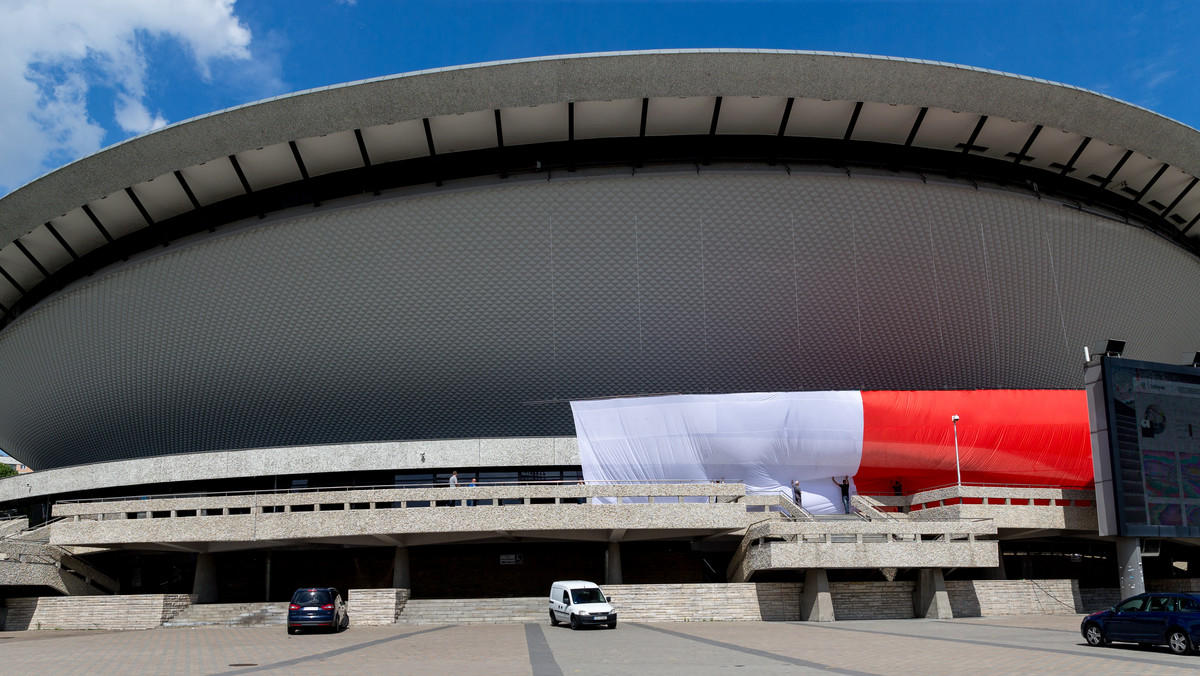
[0,616,1200,676]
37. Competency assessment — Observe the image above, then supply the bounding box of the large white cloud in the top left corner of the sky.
[0,0,260,195]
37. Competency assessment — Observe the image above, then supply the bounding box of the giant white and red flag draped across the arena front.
[571,390,1092,514]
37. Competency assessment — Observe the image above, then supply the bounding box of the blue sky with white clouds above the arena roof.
[0,0,1200,195]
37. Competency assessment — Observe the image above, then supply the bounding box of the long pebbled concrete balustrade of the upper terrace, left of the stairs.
[50,483,758,546]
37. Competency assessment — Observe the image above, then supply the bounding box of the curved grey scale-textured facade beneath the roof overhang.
[0,164,1200,468]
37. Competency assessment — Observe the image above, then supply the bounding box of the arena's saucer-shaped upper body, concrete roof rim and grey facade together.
[0,52,1200,468]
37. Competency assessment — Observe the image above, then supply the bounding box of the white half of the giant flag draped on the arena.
[571,391,863,514]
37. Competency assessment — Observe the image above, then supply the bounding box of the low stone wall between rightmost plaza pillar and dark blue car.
[946,580,1084,617]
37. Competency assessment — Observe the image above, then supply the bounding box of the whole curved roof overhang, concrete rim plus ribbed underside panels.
[0,50,1200,325]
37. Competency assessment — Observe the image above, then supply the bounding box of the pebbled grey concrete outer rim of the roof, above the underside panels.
[7,49,1200,243]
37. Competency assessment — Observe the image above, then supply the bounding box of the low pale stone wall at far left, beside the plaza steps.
[4,594,196,632]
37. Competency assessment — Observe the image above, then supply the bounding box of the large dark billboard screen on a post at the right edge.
[1088,357,1200,538]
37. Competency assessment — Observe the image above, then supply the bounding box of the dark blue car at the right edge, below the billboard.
[1079,593,1200,654]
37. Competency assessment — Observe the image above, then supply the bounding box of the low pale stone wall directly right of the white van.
[604,582,804,622]
